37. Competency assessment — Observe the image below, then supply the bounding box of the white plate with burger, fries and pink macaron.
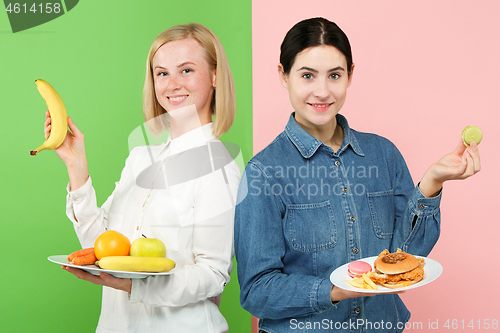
[330,249,443,294]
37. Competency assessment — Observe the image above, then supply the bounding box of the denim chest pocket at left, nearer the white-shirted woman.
[285,201,337,252]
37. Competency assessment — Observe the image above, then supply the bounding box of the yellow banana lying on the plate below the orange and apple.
[96,256,175,273]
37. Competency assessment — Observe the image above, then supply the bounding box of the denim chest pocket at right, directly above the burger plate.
[367,190,395,239]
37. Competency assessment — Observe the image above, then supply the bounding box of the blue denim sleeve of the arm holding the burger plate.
[235,162,332,319]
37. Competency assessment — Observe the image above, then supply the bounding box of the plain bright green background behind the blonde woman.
[0,0,252,332]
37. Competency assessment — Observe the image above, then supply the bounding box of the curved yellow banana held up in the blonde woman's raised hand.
[30,79,68,156]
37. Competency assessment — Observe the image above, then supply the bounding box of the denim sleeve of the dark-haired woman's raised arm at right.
[391,150,442,256]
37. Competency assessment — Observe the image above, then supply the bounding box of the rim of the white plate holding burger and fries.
[330,255,443,294]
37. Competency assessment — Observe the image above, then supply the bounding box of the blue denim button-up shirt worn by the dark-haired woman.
[235,113,441,333]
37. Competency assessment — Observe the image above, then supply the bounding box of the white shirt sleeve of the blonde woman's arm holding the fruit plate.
[130,162,241,307]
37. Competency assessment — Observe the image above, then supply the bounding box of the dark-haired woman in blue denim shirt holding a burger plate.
[235,18,480,332]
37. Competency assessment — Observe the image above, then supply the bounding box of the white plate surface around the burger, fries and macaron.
[330,256,443,294]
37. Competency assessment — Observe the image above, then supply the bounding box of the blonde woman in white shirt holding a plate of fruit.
[45,23,240,333]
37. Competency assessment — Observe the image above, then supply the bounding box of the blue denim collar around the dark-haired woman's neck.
[285,112,364,158]
